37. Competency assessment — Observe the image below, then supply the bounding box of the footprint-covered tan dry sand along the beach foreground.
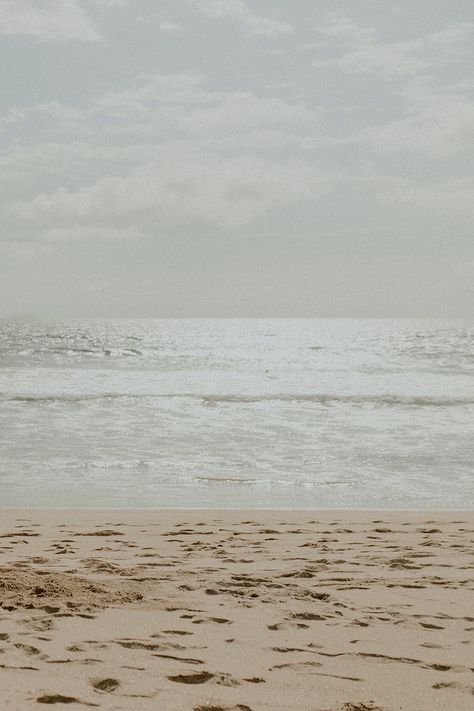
[0,511,474,711]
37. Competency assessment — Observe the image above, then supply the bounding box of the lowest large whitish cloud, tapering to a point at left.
[7,153,320,233]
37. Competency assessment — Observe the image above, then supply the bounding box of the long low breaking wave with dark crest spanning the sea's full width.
[0,393,474,407]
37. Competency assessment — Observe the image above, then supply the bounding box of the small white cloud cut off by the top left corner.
[0,0,100,42]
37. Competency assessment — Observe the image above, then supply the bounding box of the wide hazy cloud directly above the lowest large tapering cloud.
[0,73,322,153]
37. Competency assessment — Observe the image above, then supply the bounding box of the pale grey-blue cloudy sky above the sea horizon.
[0,0,474,318]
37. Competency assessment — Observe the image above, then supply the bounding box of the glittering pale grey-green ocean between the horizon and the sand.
[0,319,474,509]
